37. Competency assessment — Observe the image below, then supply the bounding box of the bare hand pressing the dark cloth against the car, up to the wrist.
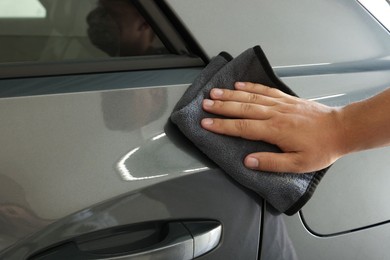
[201,82,345,173]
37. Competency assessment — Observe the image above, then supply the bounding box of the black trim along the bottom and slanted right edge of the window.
[0,0,208,79]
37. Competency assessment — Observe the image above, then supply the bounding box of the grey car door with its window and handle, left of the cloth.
[0,0,263,259]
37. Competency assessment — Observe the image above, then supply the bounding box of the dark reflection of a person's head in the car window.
[87,0,165,56]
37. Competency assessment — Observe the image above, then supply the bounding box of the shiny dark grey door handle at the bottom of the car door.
[29,221,222,260]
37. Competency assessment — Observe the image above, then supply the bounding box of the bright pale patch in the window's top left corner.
[0,0,46,18]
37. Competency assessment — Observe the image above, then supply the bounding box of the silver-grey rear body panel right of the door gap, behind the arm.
[167,0,390,259]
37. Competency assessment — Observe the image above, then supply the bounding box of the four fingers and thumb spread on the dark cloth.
[201,82,307,173]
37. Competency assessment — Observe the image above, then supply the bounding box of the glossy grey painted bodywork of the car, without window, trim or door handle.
[0,0,390,259]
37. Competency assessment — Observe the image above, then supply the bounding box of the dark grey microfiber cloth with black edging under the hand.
[171,46,329,215]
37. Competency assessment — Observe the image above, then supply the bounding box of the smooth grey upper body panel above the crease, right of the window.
[167,0,390,66]
